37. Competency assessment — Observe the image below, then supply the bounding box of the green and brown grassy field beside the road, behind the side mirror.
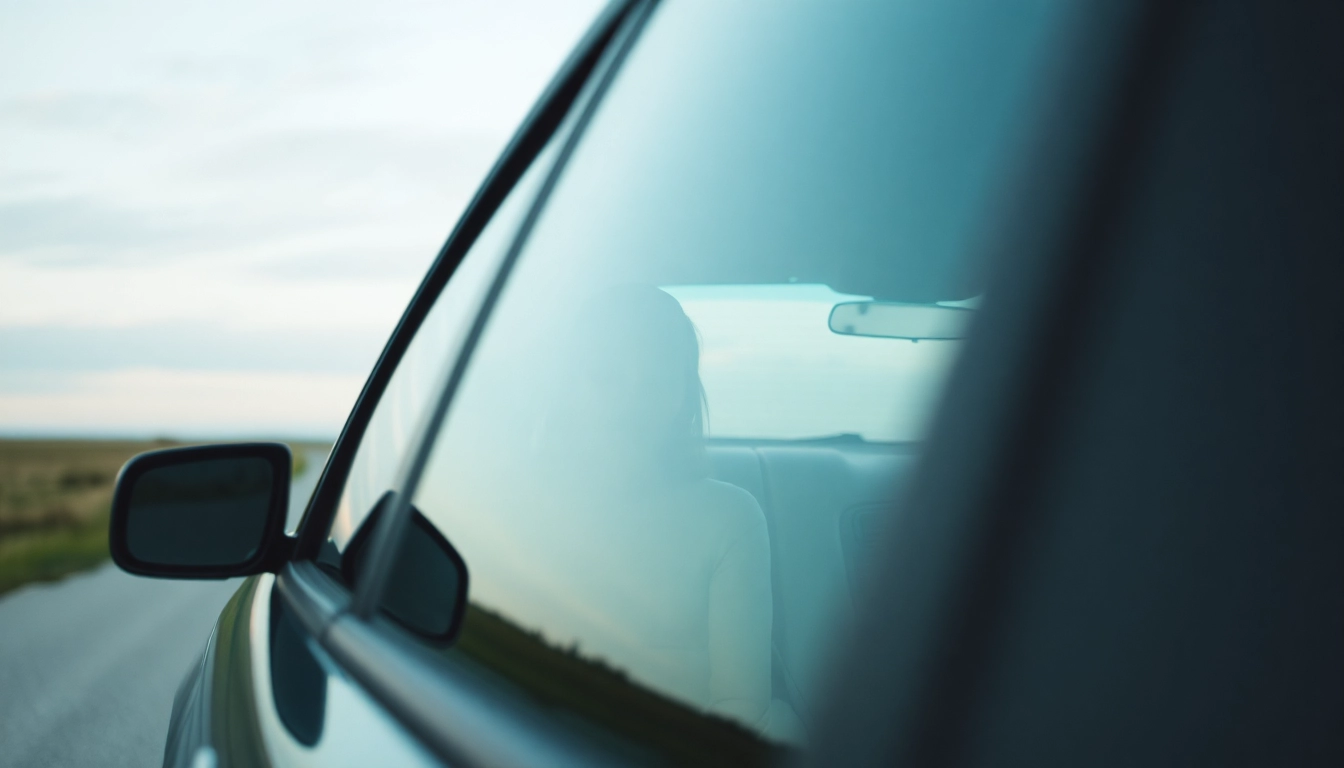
[0,440,325,594]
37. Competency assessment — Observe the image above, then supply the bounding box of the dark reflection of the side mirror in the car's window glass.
[341,491,468,646]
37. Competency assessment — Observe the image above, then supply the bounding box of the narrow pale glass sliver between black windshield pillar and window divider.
[328,141,556,554]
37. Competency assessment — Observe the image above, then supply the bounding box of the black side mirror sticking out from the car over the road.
[109,443,290,578]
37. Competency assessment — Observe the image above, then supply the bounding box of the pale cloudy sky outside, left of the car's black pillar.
[0,0,603,437]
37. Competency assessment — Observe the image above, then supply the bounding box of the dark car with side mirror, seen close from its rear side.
[110,0,1344,767]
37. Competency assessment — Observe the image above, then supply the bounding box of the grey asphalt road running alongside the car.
[0,453,325,768]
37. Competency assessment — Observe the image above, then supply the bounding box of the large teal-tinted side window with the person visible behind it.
[397,1,1051,761]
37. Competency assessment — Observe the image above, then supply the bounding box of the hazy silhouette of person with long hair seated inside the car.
[521,285,773,728]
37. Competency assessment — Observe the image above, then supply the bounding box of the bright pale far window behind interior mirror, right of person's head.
[664,284,961,443]
